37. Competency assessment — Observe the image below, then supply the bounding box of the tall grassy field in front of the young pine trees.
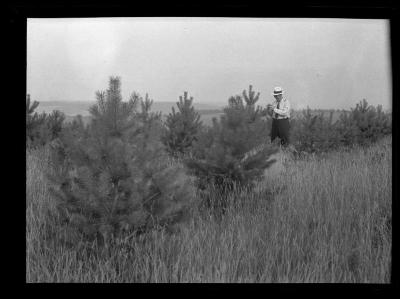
[26,138,392,283]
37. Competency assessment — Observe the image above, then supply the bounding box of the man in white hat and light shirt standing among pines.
[267,87,290,147]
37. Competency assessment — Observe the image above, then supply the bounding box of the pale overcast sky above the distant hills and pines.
[27,18,392,109]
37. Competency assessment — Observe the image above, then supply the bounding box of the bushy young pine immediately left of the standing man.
[186,86,277,199]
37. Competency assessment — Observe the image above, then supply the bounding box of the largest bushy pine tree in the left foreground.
[50,77,193,248]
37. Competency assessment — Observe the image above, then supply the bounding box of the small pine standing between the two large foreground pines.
[162,91,202,157]
